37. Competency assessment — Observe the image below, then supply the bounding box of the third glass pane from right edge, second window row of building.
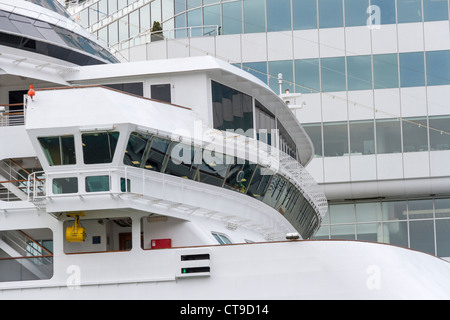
[373,53,398,89]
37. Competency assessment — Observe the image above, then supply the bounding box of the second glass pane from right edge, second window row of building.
[400,52,425,87]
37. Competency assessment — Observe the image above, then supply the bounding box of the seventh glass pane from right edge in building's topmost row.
[266,0,291,32]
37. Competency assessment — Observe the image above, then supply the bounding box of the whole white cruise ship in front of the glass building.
[0,0,450,300]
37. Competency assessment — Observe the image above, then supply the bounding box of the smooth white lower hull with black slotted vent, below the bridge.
[0,241,450,300]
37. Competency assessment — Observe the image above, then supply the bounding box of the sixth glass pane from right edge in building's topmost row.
[292,0,317,30]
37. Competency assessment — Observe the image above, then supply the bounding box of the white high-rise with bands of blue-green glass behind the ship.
[68,0,450,257]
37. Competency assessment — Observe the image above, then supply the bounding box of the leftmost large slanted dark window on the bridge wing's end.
[38,136,76,166]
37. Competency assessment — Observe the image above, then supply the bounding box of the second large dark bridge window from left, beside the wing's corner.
[82,132,119,164]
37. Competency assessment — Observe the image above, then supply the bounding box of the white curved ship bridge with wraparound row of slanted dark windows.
[26,87,327,240]
